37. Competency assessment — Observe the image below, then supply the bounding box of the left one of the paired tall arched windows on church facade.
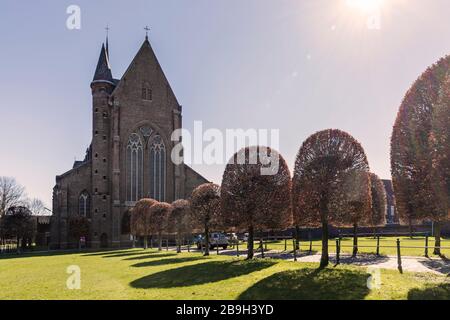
[126,133,143,201]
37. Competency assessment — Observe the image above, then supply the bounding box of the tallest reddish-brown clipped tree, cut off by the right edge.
[391,56,450,254]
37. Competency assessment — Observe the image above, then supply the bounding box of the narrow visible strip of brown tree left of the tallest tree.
[370,173,387,235]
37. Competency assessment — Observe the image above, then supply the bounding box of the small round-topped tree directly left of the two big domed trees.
[191,183,220,256]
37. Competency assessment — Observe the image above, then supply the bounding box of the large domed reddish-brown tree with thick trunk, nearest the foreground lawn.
[292,129,369,267]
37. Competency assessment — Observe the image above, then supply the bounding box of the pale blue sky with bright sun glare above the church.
[0,0,450,206]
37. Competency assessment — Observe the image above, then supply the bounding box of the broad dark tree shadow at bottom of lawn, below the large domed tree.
[239,268,369,300]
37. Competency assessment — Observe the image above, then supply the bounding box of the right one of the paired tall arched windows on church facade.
[150,135,166,201]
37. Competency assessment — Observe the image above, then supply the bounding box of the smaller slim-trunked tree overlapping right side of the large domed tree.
[330,169,372,256]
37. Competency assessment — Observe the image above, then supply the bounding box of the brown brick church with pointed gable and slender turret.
[50,37,207,249]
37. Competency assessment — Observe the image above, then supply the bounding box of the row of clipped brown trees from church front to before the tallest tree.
[131,130,386,267]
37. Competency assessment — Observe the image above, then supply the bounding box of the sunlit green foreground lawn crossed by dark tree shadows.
[0,249,450,299]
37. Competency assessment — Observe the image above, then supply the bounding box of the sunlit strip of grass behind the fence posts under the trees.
[244,237,450,257]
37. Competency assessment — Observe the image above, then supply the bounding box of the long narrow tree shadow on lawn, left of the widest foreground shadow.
[130,260,275,289]
